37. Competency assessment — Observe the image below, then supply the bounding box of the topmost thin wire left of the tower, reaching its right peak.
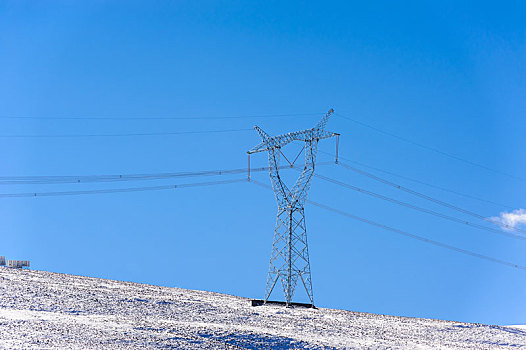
[0,113,323,120]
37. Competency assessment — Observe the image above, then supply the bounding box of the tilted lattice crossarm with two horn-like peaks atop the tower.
[247,108,338,154]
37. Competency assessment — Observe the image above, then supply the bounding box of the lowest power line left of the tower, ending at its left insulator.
[0,178,247,198]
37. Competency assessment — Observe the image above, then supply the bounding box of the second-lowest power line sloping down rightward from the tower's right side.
[314,174,526,241]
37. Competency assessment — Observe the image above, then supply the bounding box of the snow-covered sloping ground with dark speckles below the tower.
[0,268,526,349]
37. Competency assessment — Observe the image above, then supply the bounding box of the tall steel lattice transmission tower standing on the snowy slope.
[247,109,339,306]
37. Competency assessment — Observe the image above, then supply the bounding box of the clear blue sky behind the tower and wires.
[0,1,526,324]
